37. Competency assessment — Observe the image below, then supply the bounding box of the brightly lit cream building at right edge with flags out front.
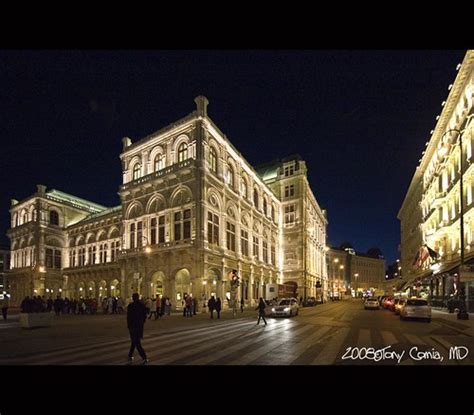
[398,50,474,309]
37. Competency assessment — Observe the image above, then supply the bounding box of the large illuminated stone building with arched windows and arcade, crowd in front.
[8,96,327,307]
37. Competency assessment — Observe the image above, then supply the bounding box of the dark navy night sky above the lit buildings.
[0,50,465,262]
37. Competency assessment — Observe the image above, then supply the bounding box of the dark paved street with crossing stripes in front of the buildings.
[0,300,474,365]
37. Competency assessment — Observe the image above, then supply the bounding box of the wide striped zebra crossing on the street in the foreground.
[0,319,462,365]
